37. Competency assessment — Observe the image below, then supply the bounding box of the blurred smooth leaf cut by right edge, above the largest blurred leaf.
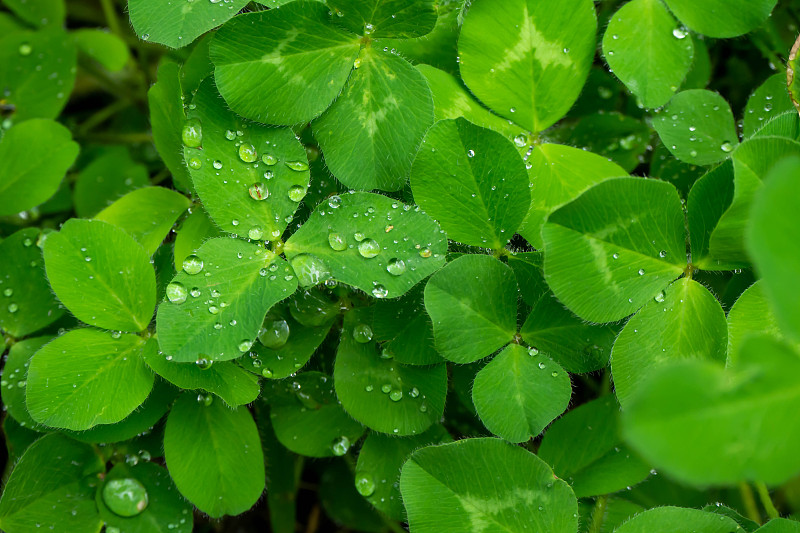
[747,157,800,340]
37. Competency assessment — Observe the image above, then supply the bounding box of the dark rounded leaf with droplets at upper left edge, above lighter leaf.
[0,28,77,121]
